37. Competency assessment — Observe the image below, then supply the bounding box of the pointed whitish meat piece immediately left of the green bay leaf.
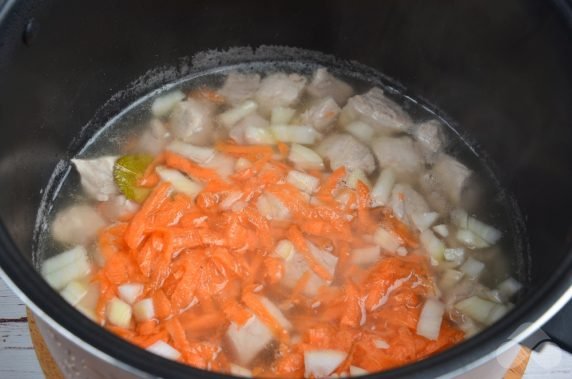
[72,156,119,201]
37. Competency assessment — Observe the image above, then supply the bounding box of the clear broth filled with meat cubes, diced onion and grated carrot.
[33,64,521,377]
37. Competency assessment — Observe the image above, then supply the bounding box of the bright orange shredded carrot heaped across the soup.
[84,114,463,378]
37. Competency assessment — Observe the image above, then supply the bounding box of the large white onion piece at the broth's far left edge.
[42,246,91,290]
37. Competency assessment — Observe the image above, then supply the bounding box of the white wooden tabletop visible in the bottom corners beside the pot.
[0,280,572,379]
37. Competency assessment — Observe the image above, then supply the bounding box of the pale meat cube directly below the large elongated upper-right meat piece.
[371,137,423,179]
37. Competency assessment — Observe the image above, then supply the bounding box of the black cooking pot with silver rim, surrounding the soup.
[0,0,572,378]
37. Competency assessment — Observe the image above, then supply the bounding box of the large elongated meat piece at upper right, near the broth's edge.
[342,87,411,132]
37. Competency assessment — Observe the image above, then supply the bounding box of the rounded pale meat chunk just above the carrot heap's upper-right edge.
[317,133,375,174]
